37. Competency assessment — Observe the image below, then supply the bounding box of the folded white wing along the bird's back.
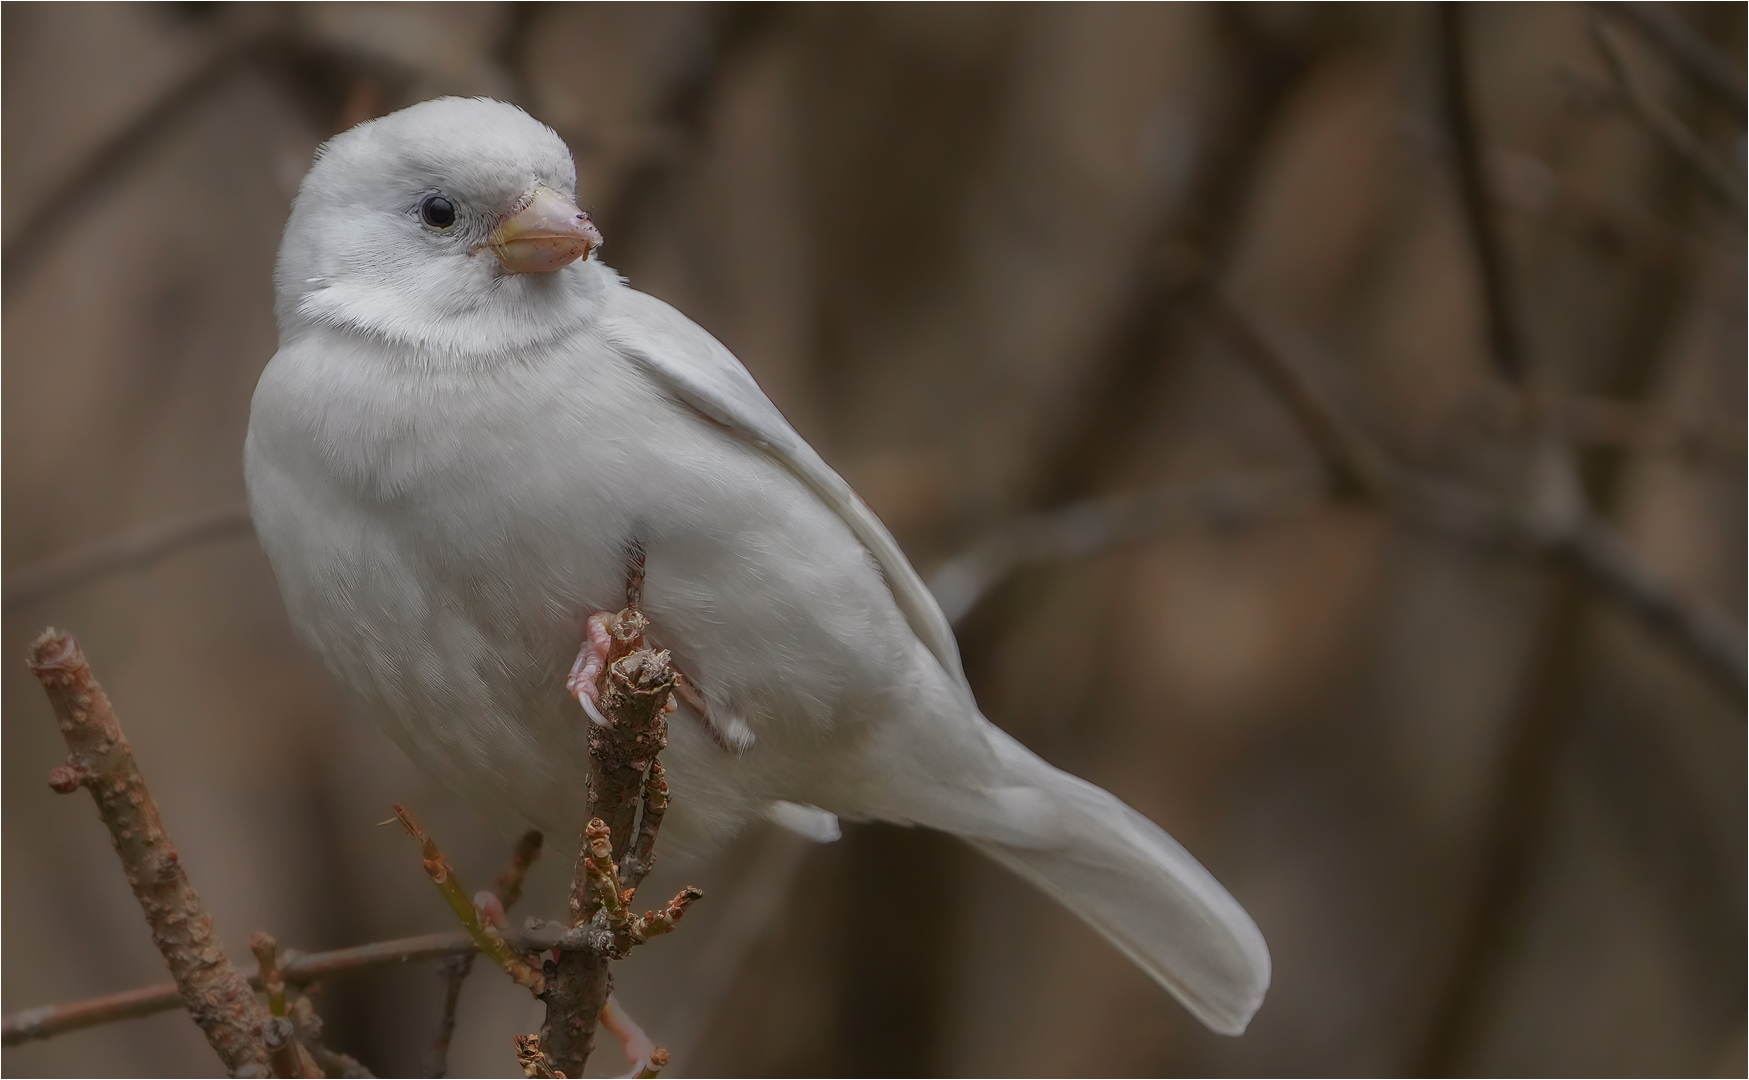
[605,281,965,683]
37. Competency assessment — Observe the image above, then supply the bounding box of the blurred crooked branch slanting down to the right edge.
[1205,289,1749,705]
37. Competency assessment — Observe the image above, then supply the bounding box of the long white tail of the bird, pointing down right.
[913,721,1270,1034]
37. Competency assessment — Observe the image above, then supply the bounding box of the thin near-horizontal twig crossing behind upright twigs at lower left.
[0,924,587,1047]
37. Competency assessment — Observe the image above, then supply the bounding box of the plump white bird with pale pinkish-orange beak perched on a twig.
[245,98,1270,1034]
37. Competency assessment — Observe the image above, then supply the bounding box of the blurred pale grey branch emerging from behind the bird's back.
[929,471,1329,623]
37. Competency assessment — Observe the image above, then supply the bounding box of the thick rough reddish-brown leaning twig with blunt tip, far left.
[30,630,268,1073]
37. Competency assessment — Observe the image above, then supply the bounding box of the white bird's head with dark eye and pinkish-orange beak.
[276,98,602,354]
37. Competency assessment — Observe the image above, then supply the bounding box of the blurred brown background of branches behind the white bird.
[0,4,1746,1076]
